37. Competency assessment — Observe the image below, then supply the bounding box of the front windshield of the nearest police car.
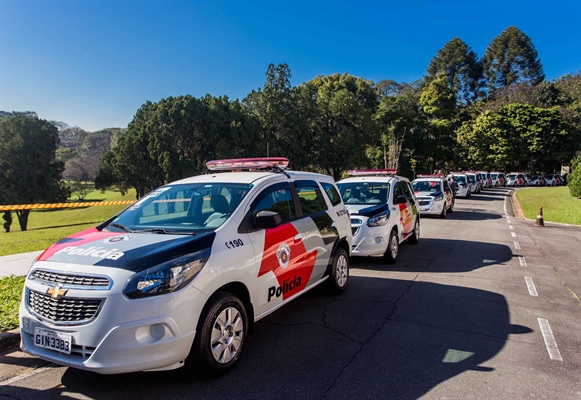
[106,182,251,235]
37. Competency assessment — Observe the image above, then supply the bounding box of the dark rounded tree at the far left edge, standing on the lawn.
[0,116,68,231]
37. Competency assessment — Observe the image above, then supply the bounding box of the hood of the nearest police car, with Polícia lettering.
[36,228,216,272]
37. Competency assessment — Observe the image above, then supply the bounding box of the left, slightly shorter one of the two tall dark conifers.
[426,38,483,104]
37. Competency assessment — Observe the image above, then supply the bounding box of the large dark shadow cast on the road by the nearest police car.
[0,276,531,399]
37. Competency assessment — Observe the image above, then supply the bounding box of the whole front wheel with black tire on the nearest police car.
[186,292,248,376]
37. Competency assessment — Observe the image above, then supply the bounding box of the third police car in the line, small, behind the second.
[412,175,454,218]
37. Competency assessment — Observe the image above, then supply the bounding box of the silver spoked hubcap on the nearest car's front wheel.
[210,307,244,364]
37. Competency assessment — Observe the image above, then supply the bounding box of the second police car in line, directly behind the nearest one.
[337,170,420,264]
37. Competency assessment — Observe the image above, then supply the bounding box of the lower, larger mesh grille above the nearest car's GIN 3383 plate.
[27,289,103,324]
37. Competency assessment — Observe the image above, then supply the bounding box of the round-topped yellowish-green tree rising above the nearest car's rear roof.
[303,74,379,180]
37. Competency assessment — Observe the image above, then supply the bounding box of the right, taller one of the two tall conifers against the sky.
[482,26,545,93]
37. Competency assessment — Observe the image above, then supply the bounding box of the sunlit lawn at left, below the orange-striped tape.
[0,190,135,256]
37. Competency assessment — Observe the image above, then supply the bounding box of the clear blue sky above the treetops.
[0,0,581,131]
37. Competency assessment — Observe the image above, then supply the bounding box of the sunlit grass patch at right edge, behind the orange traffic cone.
[516,186,581,225]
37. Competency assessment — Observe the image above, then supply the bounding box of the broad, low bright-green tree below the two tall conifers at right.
[458,104,577,171]
